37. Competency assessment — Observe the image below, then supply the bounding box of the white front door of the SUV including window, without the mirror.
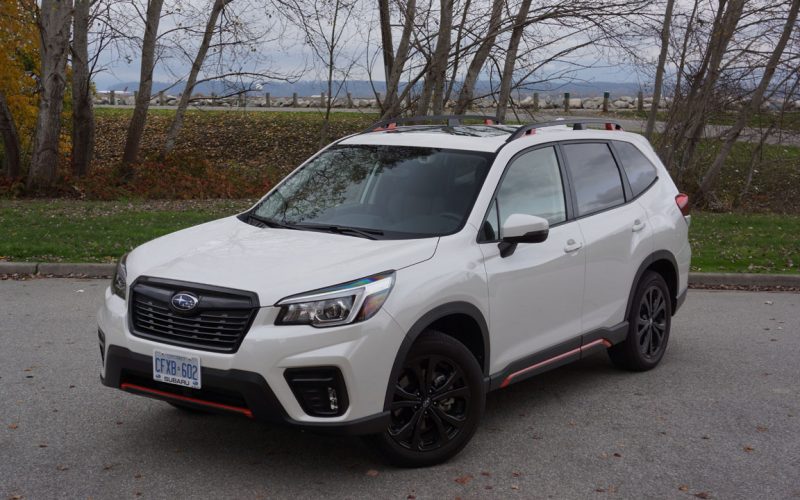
[479,145,585,367]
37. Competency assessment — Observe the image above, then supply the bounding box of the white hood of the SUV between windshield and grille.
[127,217,439,306]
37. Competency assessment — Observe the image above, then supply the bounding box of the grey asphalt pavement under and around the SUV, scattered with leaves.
[0,279,800,499]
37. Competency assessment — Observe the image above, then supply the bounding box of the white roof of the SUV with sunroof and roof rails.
[339,122,646,152]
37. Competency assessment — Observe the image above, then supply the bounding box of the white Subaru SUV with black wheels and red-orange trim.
[98,117,691,466]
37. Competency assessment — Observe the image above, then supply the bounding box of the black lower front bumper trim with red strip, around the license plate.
[101,345,389,435]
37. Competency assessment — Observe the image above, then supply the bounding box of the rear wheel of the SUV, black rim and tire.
[608,271,672,372]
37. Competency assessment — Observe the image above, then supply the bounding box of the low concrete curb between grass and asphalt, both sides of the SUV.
[0,262,800,287]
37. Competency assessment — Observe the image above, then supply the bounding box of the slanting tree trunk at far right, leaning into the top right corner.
[700,0,800,197]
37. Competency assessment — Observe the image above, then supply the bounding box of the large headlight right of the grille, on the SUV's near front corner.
[275,271,394,327]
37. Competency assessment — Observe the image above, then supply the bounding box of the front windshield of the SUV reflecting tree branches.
[250,146,493,239]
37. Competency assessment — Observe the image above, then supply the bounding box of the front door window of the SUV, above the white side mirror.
[483,146,567,241]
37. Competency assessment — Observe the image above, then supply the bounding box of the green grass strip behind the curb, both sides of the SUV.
[0,200,800,273]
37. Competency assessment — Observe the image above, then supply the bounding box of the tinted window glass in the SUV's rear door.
[561,143,625,216]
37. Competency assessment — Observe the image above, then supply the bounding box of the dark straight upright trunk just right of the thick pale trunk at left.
[72,0,95,177]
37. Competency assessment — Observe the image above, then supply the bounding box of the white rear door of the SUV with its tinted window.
[561,141,652,332]
